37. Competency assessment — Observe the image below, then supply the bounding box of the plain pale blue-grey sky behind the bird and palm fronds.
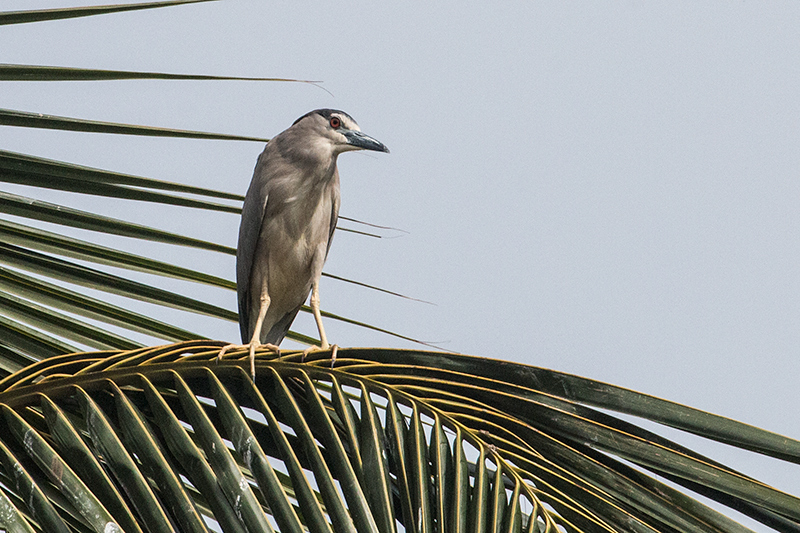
[0,0,800,531]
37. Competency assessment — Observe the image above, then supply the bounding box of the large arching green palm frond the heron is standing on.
[0,341,800,533]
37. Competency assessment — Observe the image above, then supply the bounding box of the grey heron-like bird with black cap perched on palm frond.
[218,109,389,378]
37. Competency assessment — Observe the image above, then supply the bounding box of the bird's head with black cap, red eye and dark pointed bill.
[290,109,389,156]
